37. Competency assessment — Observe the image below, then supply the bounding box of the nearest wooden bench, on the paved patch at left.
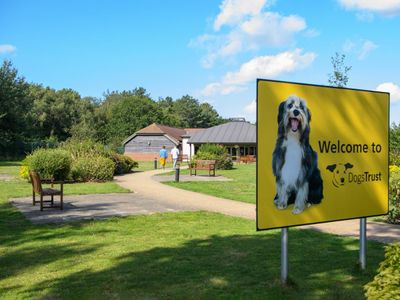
[29,171,64,211]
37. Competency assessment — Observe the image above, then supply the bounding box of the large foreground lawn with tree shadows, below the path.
[0,163,383,299]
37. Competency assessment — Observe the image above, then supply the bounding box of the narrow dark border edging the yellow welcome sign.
[256,78,390,231]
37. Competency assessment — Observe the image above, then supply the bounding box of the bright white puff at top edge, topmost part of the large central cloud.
[214,0,267,31]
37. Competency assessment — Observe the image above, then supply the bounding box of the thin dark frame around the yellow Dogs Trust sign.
[256,78,390,231]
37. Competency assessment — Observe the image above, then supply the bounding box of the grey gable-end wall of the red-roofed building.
[124,135,175,160]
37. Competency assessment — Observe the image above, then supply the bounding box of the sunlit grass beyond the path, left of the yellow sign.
[163,164,256,203]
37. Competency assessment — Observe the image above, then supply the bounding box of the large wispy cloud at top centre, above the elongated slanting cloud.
[189,0,310,68]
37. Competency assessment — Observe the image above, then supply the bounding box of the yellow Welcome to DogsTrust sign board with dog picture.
[257,80,389,230]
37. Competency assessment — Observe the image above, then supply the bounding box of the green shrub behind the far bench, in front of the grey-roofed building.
[194,144,233,170]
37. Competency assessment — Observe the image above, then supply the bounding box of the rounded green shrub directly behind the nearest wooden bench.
[27,149,71,180]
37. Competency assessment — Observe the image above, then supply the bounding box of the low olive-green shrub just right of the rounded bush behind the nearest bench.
[71,155,115,181]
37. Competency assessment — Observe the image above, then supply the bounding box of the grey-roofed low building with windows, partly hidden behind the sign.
[188,118,257,158]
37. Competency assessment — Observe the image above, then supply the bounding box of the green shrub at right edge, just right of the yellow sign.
[387,167,400,224]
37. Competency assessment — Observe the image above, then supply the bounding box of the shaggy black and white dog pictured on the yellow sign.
[272,95,323,214]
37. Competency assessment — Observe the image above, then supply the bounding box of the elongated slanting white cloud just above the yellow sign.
[201,49,316,96]
